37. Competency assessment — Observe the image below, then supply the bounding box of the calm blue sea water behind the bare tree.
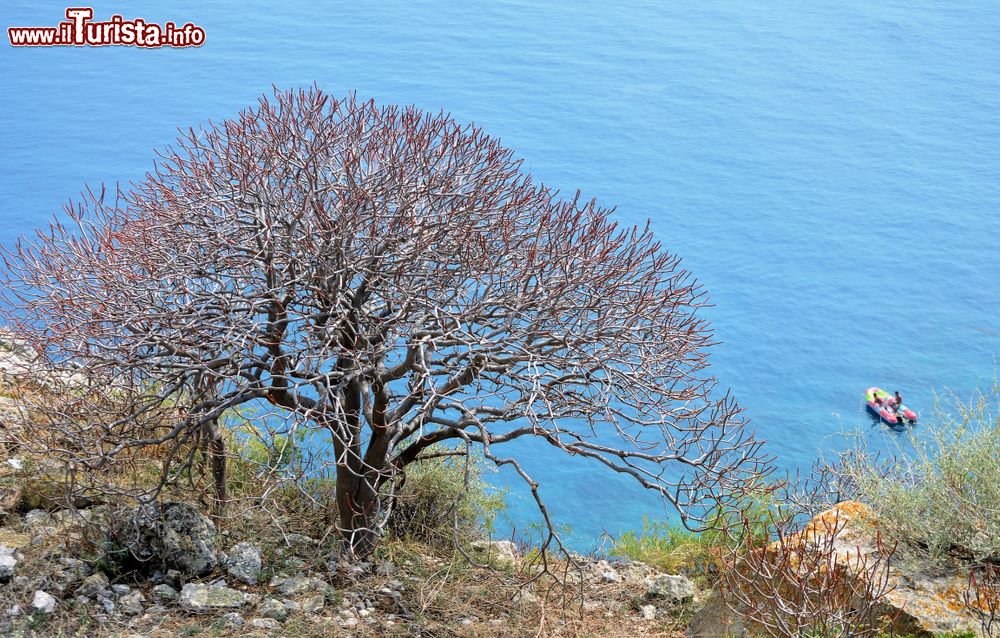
[0,0,1000,547]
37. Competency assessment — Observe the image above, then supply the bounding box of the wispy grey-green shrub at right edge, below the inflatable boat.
[844,383,1000,560]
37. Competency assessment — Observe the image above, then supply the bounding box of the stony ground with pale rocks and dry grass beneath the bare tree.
[0,503,697,637]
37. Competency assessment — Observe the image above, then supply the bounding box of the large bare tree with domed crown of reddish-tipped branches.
[3,89,765,555]
